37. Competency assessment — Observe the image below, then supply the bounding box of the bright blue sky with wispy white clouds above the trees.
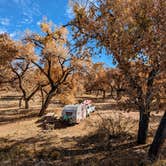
[0,0,112,66]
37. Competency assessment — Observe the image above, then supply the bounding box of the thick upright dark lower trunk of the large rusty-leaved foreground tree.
[137,110,150,144]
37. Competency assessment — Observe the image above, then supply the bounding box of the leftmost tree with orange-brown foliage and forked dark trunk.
[0,34,46,109]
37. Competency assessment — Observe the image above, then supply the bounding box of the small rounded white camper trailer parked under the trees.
[62,104,87,124]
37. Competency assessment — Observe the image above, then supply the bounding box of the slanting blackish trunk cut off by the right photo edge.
[148,111,166,161]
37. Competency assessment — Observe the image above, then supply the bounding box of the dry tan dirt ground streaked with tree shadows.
[0,91,166,166]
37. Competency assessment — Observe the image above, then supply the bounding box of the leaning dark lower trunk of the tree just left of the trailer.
[39,89,56,116]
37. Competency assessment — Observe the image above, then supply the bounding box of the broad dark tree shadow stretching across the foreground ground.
[0,131,166,166]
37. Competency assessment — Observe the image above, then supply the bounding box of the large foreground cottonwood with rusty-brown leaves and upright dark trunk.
[66,0,166,149]
